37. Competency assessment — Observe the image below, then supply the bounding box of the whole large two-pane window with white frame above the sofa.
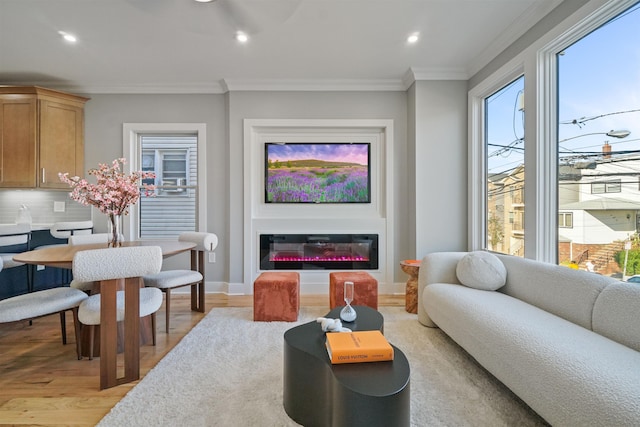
[469,0,640,268]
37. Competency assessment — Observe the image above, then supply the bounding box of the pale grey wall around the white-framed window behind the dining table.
[85,94,228,282]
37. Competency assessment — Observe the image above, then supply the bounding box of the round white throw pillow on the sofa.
[456,251,507,291]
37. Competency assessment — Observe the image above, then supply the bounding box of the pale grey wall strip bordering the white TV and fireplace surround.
[228,92,408,290]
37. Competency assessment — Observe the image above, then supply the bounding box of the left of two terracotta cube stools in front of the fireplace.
[253,271,300,322]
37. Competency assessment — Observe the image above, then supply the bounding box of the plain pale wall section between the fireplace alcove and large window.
[410,81,468,259]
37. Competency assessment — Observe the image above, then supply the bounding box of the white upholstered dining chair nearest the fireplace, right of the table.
[143,232,218,333]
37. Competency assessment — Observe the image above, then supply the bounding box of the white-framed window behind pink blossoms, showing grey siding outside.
[123,123,206,239]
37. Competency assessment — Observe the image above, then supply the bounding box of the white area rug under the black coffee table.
[98,307,545,427]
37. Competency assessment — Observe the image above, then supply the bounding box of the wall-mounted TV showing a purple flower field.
[264,142,371,203]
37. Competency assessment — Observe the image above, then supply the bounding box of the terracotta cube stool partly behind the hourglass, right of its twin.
[329,271,378,310]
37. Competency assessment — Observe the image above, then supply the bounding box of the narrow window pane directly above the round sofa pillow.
[484,77,524,256]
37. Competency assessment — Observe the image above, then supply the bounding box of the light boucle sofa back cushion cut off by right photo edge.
[593,282,640,351]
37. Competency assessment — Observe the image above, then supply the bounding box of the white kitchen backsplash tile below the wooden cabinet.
[0,190,91,224]
